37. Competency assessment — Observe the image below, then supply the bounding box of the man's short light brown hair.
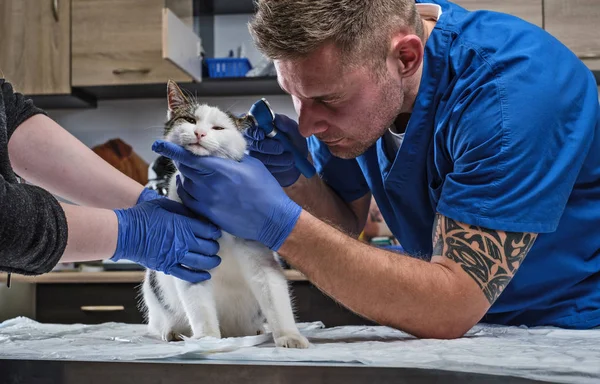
[249,0,423,68]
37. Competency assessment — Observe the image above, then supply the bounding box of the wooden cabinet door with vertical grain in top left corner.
[0,0,71,95]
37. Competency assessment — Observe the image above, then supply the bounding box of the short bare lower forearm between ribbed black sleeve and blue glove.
[60,204,119,262]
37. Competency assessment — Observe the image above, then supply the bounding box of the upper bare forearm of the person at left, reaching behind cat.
[8,115,143,209]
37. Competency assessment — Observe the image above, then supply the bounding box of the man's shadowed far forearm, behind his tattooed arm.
[285,175,371,238]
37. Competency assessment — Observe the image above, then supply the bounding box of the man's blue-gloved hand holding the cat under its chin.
[152,140,302,251]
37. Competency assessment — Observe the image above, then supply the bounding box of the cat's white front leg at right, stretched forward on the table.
[238,241,309,348]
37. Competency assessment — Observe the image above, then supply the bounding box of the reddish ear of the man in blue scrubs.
[388,33,425,78]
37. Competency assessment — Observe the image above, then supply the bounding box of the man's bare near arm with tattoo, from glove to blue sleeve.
[278,211,536,339]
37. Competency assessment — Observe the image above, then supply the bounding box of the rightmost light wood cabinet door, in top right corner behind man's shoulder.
[544,0,600,70]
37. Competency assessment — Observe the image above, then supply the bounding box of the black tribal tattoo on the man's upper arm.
[433,214,537,304]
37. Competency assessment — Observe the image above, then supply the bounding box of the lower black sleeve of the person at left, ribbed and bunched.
[0,176,67,275]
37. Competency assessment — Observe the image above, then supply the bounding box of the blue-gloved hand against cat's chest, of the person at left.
[111,199,221,283]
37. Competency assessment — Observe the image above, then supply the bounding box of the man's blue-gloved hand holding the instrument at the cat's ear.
[244,114,308,187]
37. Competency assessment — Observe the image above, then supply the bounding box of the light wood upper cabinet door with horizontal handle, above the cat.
[72,0,200,87]
